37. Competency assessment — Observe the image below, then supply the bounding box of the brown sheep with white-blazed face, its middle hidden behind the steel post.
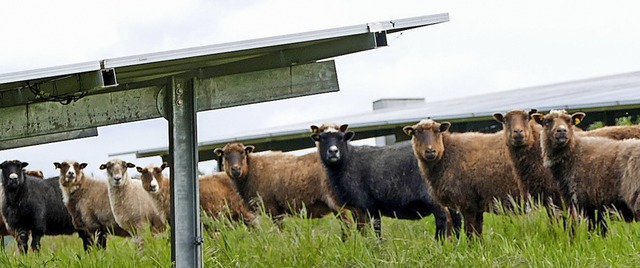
[136,162,255,225]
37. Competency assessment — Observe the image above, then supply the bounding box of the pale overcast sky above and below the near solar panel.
[0,0,640,177]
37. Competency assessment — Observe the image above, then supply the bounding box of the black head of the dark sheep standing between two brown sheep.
[311,131,354,165]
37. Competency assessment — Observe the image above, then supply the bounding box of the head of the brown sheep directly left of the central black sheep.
[215,143,255,180]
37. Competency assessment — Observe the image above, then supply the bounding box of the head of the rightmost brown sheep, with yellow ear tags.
[533,110,585,148]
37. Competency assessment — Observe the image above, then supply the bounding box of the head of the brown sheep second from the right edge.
[493,109,537,147]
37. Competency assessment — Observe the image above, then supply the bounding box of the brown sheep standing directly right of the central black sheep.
[403,119,524,238]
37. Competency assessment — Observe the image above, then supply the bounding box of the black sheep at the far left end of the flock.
[0,160,90,253]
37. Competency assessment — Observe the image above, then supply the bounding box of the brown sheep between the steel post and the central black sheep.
[215,143,340,224]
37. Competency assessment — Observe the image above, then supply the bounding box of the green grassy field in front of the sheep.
[0,206,640,267]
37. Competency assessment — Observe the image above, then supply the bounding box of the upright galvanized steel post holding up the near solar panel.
[166,76,203,267]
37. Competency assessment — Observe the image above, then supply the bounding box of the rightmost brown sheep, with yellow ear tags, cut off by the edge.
[532,110,640,236]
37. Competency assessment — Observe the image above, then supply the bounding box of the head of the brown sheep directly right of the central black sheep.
[402,119,451,162]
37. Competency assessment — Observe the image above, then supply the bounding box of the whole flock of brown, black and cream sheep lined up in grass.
[0,110,640,253]
